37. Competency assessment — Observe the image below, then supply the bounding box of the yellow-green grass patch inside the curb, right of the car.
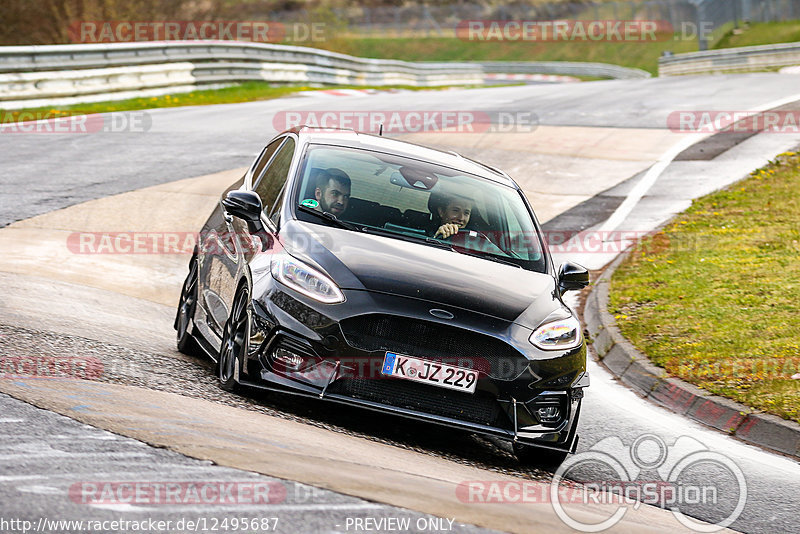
[609,153,800,422]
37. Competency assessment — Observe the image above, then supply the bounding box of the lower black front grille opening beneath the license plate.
[328,378,507,426]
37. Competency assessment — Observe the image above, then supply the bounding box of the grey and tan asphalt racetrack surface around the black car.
[0,74,800,532]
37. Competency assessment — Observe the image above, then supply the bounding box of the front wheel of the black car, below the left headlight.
[217,287,250,392]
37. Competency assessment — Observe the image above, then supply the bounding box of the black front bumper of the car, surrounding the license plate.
[244,282,588,451]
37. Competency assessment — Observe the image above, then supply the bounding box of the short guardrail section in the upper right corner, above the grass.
[658,42,800,76]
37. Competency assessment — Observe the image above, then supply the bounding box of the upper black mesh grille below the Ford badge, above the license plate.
[340,314,528,380]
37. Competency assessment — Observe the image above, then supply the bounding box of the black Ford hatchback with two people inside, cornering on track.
[175,127,589,463]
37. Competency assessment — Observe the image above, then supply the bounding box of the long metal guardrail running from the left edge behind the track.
[0,41,649,109]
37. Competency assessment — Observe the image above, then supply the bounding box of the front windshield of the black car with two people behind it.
[295,145,546,272]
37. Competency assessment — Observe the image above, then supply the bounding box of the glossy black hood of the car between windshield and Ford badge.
[281,220,560,328]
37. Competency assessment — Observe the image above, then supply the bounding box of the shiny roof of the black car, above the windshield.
[282,126,519,189]
